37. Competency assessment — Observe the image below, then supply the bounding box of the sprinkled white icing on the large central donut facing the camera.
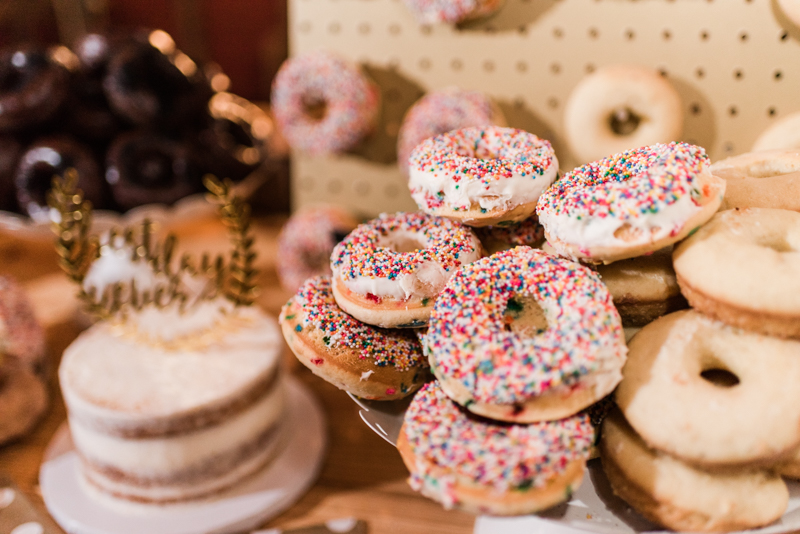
[427,247,627,404]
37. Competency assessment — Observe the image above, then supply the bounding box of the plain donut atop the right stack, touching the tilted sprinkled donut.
[709,150,800,211]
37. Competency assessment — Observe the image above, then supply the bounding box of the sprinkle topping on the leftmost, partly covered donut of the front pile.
[286,276,427,371]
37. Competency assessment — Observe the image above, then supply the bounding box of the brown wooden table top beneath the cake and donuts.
[0,217,474,534]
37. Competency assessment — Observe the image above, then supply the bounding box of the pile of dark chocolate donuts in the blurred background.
[0,30,274,221]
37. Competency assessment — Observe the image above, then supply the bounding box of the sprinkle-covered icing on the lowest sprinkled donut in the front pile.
[404,382,595,508]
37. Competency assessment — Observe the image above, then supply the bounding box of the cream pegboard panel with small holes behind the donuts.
[289,0,800,215]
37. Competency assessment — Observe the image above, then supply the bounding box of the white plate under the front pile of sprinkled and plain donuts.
[350,395,800,534]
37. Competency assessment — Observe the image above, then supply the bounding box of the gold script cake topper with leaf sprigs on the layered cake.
[48,169,258,319]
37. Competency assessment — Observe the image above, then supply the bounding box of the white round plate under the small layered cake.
[39,377,327,534]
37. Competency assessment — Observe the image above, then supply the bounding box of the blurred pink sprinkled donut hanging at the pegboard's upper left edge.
[270,52,380,155]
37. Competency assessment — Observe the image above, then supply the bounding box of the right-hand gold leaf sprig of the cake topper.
[203,174,258,306]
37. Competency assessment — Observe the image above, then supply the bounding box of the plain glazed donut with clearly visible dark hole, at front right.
[616,310,800,467]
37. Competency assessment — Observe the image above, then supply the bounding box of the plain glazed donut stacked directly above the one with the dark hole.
[673,208,800,338]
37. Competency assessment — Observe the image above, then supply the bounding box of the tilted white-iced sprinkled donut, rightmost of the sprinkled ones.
[536,143,725,263]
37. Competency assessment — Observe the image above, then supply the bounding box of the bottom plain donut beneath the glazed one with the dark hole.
[600,410,789,532]
